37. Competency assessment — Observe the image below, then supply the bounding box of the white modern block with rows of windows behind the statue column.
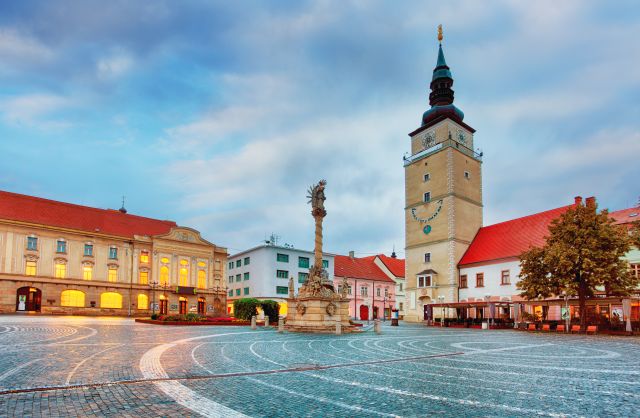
[227,244,334,315]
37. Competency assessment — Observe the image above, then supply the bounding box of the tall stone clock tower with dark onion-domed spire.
[404,26,482,321]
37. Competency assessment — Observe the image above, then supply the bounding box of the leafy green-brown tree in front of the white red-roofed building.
[518,201,638,331]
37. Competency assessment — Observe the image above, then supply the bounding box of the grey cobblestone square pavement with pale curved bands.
[0,316,640,417]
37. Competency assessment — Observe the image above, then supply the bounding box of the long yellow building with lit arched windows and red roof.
[0,191,227,316]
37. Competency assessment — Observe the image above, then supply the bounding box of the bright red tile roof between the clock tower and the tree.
[458,205,574,266]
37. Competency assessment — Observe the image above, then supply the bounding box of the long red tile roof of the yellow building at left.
[0,191,177,238]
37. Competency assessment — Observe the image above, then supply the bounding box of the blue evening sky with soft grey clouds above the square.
[0,0,640,257]
